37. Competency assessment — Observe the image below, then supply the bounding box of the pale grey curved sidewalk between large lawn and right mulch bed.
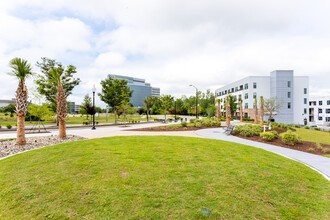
[195,128,330,180]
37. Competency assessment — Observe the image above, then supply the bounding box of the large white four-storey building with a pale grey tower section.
[215,70,309,124]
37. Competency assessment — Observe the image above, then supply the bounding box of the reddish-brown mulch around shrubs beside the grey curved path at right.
[232,128,330,155]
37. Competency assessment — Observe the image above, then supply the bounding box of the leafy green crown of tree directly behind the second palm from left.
[35,57,81,112]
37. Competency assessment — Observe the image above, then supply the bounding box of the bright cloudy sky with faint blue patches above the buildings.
[0,0,330,106]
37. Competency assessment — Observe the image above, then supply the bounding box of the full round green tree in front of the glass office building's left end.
[98,76,133,124]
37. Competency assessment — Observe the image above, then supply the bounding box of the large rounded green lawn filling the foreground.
[0,136,330,219]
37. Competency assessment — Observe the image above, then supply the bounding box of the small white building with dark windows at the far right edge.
[309,96,330,126]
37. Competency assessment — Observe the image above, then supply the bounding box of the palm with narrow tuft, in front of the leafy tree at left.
[50,68,67,138]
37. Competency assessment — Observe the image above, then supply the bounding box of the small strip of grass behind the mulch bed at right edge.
[294,128,330,145]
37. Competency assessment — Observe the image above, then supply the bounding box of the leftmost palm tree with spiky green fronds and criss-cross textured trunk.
[8,57,33,146]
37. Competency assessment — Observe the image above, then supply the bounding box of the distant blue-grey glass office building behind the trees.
[109,74,160,107]
